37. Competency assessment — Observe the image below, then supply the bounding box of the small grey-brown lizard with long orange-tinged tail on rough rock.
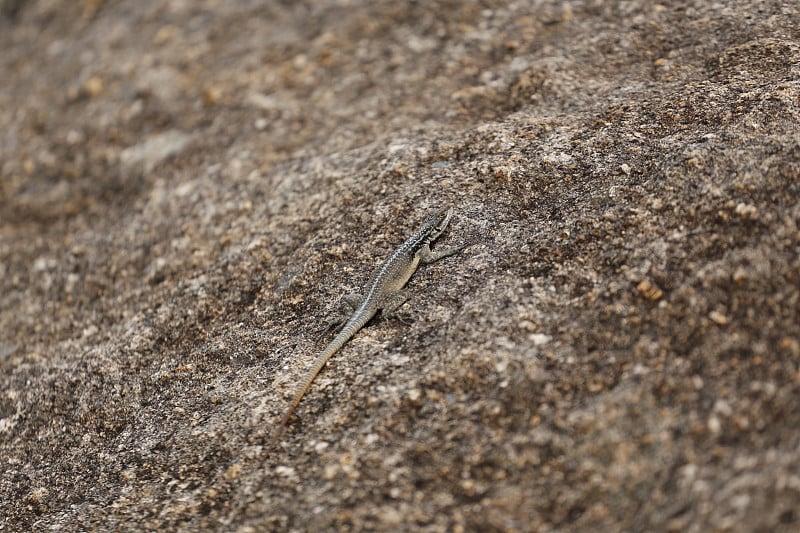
[267,208,467,450]
